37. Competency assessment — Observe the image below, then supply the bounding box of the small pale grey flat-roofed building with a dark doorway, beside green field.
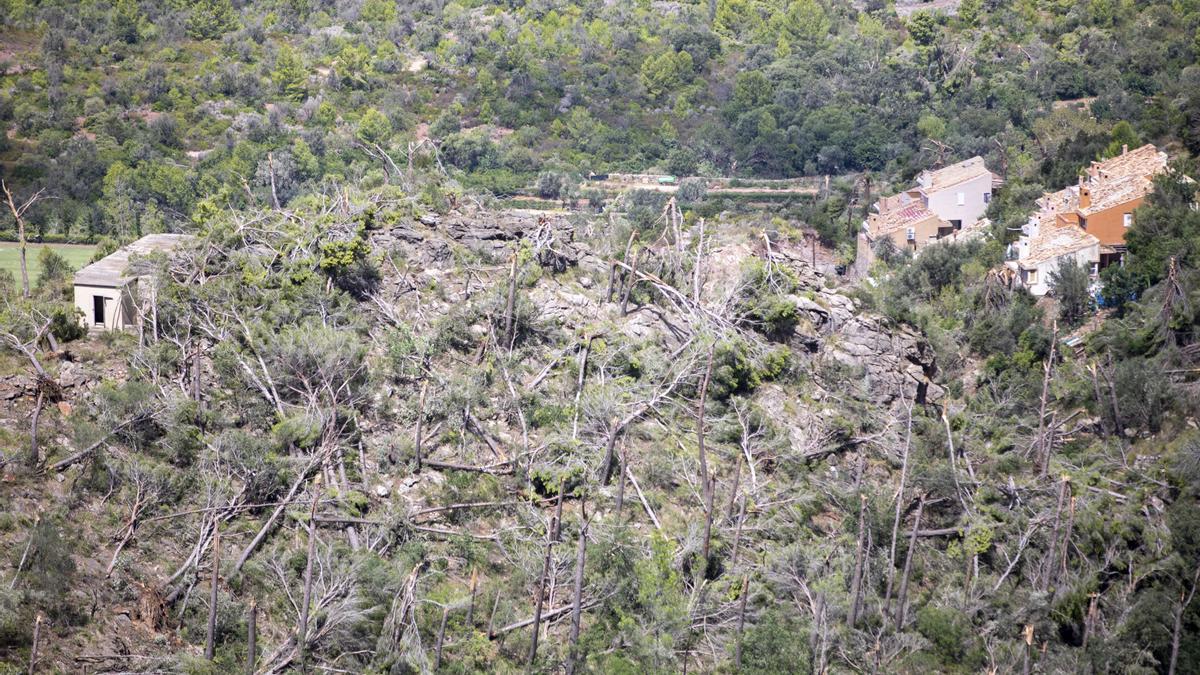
[74,234,193,330]
